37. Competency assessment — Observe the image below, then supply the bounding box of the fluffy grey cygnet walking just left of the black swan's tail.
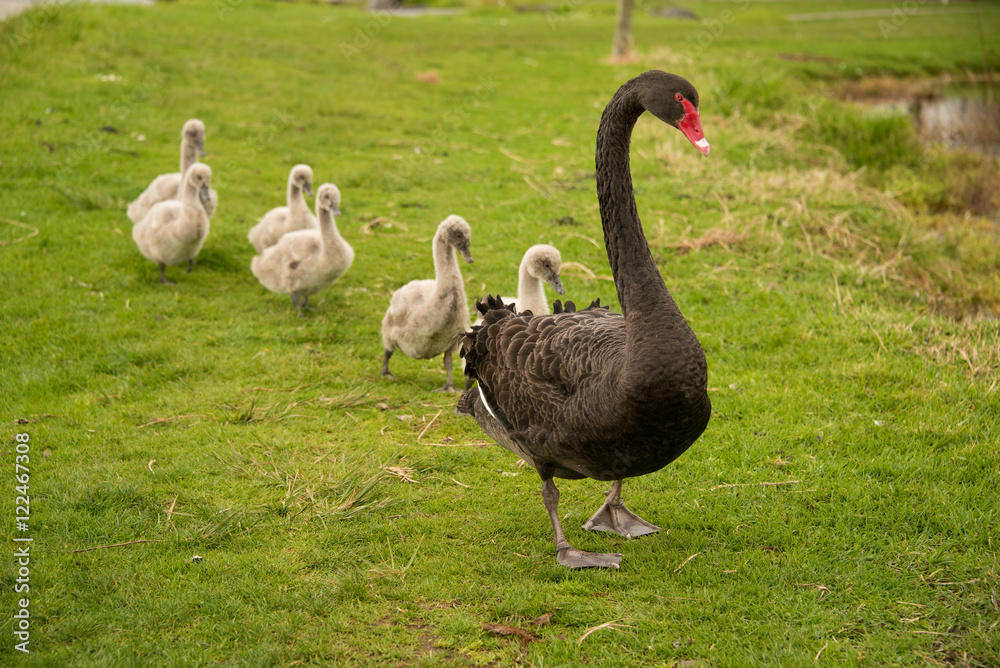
[382,215,472,392]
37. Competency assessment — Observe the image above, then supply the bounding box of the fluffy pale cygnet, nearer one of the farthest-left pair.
[132,164,212,284]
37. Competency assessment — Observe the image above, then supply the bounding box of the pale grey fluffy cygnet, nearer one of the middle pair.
[250,183,354,316]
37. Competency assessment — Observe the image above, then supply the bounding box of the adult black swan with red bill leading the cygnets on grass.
[458,70,712,568]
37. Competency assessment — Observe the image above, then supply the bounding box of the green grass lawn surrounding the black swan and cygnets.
[0,0,1000,667]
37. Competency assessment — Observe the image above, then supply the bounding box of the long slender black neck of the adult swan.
[596,79,680,316]
